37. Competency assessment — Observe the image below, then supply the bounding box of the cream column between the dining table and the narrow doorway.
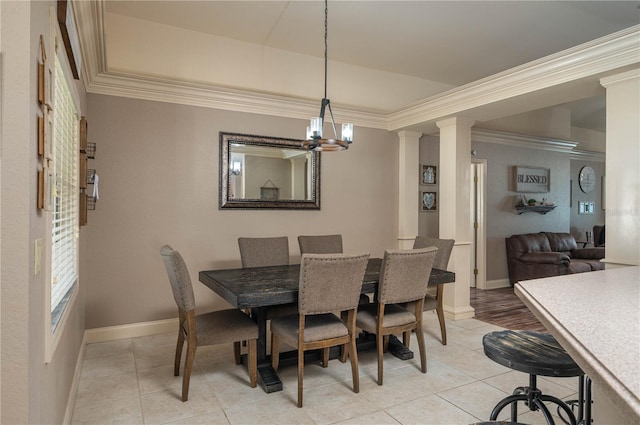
[436,118,475,320]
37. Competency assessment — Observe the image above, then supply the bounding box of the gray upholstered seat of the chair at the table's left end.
[192,309,258,345]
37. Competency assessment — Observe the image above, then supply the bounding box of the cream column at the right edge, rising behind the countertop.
[600,69,640,269]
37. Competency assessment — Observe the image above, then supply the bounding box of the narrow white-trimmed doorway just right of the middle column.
[470,158,487,289]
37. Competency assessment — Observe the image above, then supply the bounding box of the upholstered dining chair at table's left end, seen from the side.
[160,245,258,401]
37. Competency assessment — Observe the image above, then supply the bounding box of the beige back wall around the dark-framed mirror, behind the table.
[82,95,398,329]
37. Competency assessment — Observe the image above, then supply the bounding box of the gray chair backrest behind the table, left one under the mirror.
[238,236,289,267]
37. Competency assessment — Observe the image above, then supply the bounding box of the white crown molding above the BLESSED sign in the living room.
[471,128,578,153]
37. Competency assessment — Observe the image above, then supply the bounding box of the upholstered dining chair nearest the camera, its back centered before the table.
[271,254,369,407]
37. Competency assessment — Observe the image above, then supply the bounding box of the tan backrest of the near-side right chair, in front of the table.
[378,247,438,304]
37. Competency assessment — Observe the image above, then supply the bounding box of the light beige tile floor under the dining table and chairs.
[71,313,578,425]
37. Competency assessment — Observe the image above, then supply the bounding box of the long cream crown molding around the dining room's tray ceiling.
[73,0,640,136]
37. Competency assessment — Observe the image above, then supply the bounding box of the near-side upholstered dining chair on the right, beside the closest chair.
[356,247,437,385]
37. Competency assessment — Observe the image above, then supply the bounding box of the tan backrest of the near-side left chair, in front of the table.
[298,253,369,315]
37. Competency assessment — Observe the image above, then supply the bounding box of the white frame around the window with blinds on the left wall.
[43,7,82,363]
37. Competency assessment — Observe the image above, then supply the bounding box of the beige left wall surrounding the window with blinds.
[0,1,84,424]
